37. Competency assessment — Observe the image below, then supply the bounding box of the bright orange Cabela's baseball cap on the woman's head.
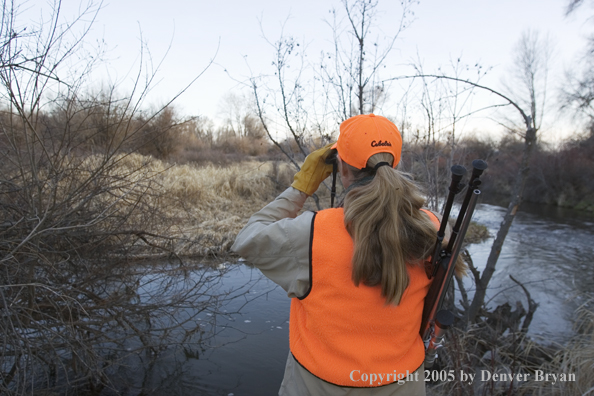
[332,114,402,169]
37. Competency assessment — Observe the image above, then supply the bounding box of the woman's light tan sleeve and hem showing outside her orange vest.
[231,187,425,396]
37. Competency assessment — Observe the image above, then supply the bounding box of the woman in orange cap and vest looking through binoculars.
[232,114,438,396]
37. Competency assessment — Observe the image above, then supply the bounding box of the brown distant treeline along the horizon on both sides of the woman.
[5,102,594,212]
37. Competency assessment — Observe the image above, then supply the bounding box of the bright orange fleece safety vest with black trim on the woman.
[289,208,439,387]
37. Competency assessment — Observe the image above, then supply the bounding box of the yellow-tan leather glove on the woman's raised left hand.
[291,143,334,195]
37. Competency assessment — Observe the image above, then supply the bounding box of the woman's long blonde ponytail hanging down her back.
[343,153,436,305]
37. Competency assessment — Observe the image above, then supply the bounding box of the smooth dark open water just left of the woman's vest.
[102,263,290,396]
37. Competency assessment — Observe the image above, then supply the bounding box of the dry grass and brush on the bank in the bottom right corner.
[428,298,594,396]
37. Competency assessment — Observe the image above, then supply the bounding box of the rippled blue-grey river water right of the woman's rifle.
[466,204,594,342]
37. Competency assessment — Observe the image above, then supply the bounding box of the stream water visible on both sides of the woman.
[103,203,594,396]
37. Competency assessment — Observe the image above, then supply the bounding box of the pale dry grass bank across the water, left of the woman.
[22,153,330,257]
